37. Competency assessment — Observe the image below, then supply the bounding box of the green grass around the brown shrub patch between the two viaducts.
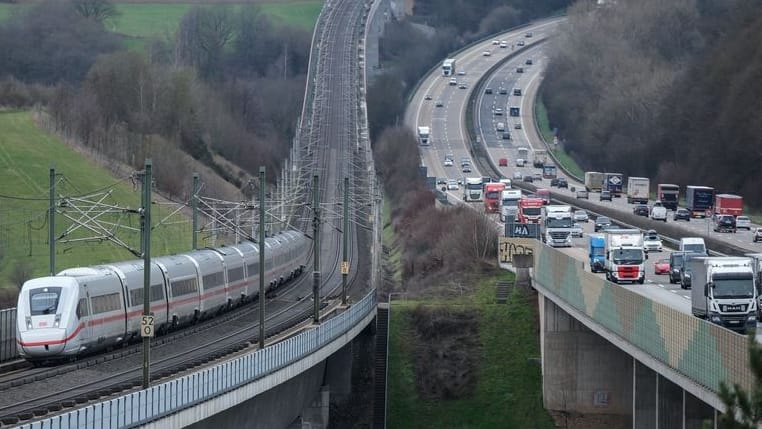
[388,274,554,429]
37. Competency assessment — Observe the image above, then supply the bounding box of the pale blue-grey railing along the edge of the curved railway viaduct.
[19,290,376,429]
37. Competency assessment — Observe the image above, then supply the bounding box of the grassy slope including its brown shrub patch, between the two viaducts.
[388,274,555,429]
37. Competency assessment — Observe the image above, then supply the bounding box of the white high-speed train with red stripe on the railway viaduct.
[16,231,311,362]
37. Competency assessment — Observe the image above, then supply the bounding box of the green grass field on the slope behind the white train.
[0,111,191,287]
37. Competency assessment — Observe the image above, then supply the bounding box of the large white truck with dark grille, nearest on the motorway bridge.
[686,257,758,333]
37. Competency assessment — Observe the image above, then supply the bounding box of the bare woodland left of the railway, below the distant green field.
[0,0,311,198]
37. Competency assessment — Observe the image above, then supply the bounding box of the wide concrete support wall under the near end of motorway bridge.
[539,295,633,429]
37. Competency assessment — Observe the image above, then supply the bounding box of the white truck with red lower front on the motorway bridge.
[605,229,646,284]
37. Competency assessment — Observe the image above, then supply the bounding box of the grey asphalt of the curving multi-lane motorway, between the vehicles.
[406,21,762,340]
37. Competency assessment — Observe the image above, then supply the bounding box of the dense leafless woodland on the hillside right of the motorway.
[543,0,762,207]
